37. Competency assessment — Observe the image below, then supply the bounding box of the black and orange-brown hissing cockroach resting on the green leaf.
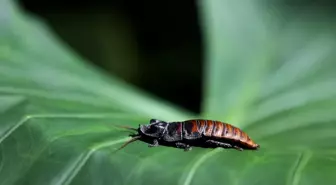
[115,119,260,151]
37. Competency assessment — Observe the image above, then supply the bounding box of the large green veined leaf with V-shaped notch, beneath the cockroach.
[0,0,336,185]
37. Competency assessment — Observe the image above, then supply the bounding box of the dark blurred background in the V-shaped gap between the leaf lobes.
[20,0,204,112]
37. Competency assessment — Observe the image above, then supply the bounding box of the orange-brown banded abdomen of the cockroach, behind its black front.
[188,120,257,147]
